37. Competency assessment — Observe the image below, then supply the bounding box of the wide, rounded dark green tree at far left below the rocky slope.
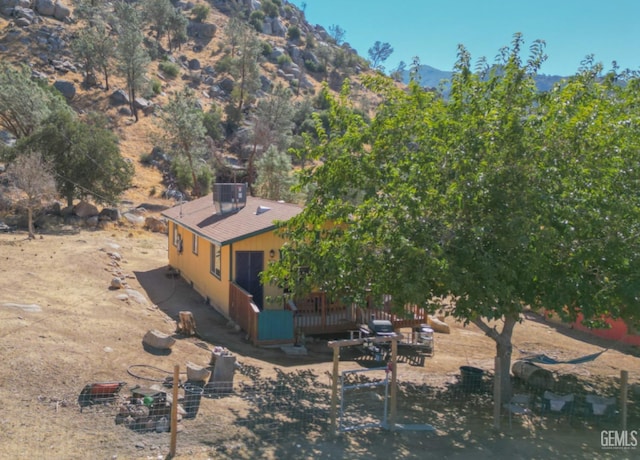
[15,111,134,206]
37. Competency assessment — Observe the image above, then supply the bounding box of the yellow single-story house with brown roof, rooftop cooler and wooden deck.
[162,184,425,344]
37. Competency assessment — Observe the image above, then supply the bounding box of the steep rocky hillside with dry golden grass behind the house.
[0,0,380,217]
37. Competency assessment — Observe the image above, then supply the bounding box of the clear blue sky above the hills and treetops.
[291,0,640,76]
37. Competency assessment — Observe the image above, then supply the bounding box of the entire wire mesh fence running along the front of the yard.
[51,365,640,459]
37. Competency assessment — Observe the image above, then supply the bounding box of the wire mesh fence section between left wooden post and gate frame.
[177,366,331,458]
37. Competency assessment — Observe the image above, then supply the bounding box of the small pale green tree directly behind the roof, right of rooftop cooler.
[255,145,295,201]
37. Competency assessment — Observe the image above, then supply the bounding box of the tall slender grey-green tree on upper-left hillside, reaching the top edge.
[116,2,150,121]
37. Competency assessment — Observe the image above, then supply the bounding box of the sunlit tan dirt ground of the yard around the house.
[0,227,640,459]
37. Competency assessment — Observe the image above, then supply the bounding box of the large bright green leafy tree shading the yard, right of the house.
[265,35,640,398]
